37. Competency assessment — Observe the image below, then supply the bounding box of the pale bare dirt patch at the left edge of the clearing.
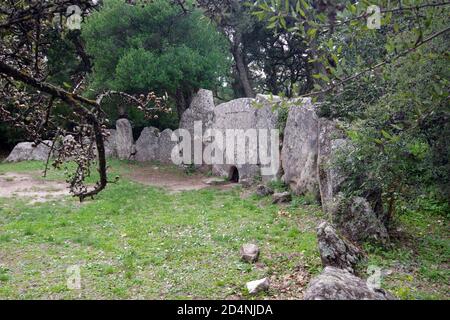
[0,172,70,203]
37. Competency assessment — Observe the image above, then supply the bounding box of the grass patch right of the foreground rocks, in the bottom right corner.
[365,210,450,300]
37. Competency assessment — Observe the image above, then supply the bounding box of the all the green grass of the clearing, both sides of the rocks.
[0,161,449,299]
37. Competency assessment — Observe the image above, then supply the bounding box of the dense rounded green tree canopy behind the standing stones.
[82,0,230,109]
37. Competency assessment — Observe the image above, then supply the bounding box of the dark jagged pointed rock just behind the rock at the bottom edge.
[317,222,363,273]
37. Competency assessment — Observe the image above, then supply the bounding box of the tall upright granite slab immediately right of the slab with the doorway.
[281,99,319,198]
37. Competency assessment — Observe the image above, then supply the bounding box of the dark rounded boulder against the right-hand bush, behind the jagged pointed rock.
[330,195,389,243]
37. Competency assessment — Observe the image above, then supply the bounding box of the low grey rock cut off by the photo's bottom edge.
[303,267,394,300]
